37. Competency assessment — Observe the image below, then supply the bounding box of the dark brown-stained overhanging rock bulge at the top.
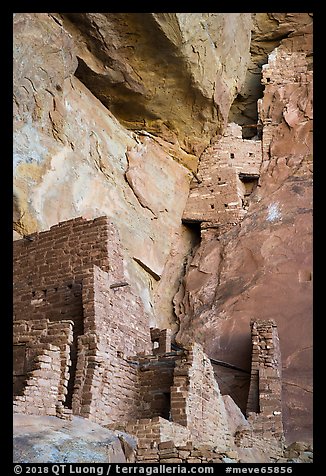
[62,13,251,155]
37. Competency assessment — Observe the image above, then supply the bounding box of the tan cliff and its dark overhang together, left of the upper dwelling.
[14,13,251,328]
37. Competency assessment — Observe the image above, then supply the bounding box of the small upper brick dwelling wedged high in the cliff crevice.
[182,123,262,226]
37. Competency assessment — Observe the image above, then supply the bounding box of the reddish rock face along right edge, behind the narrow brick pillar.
[175,16,312,442]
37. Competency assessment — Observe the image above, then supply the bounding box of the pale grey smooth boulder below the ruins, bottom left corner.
[13,414,136,463]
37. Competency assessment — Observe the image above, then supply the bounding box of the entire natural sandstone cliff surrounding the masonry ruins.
[14,13,312,441]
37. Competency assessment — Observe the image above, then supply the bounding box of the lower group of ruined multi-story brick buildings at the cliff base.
[14,217,281,461]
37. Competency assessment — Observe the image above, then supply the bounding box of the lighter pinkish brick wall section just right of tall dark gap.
[73,266,151,424]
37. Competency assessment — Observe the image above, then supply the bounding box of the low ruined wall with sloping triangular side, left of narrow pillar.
[109,344,233,459]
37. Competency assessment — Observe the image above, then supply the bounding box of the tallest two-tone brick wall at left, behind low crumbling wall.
[14,217,152,423]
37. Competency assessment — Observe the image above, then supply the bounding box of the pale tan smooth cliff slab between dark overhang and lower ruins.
[14,14,199,327]
